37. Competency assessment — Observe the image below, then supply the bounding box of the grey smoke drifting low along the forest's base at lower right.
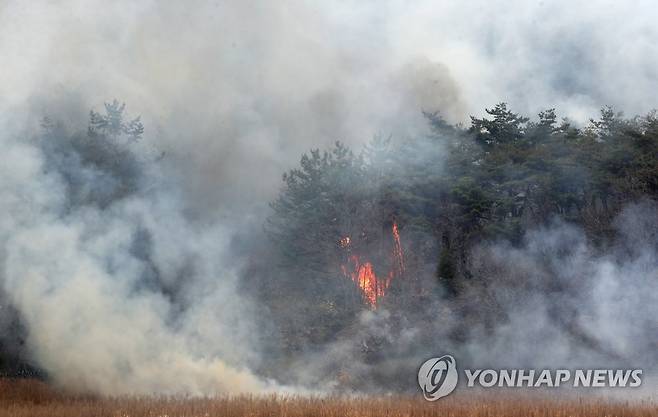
[293,201,658,399]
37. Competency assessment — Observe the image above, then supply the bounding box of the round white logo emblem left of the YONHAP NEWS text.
[418,355,458,401]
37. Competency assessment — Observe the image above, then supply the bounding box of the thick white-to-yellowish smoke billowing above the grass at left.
[0,112,266,394]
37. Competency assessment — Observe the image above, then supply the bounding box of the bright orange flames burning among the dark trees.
[338,222,404,309]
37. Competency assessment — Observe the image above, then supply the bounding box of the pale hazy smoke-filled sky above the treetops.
[0,0,658,206]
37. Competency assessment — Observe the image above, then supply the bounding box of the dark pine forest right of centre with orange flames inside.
[262,103,658,382]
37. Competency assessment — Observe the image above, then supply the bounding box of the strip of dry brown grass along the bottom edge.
[0,379,658,417]
